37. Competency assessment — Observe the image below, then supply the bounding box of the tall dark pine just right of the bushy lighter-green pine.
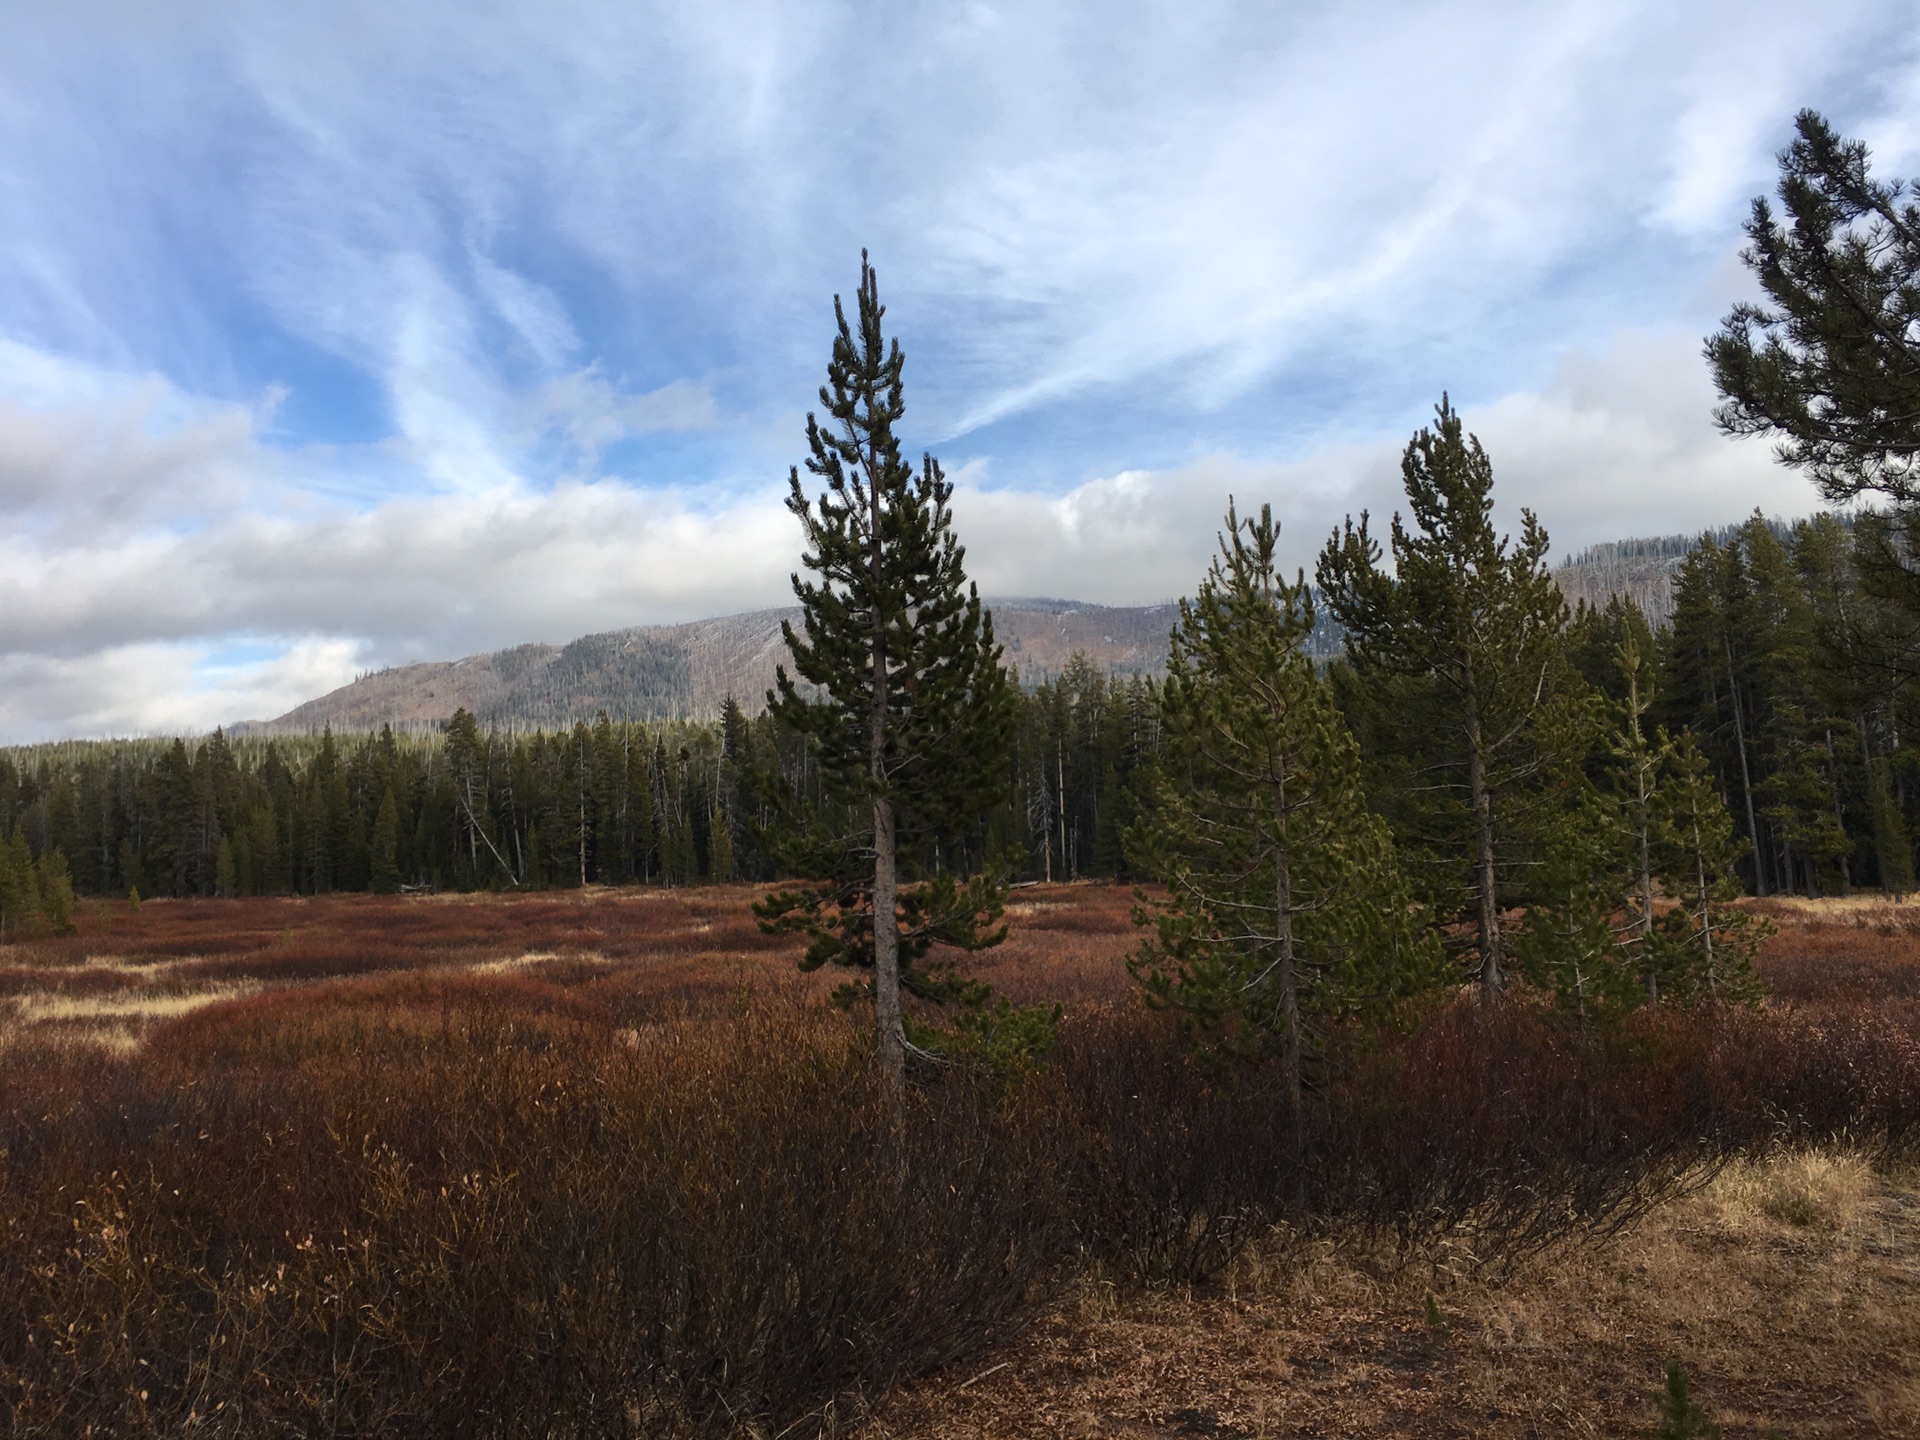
[1319,397,1567,995]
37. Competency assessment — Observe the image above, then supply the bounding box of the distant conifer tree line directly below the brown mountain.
[0,683,1158,916]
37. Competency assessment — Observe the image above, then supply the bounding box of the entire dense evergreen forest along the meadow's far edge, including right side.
[0,515,1920,936]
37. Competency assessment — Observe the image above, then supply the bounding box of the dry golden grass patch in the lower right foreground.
[875,1150,1920,1440]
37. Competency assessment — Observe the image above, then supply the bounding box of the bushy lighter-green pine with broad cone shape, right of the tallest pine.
[1129,507,1438,1137]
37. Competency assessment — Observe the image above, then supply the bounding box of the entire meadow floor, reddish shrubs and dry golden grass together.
[0,885,1920,1438]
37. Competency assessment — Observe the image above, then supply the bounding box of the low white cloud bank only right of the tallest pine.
[954,332,1816,605]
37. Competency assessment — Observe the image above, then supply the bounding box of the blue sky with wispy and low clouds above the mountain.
[0,0,1920,741]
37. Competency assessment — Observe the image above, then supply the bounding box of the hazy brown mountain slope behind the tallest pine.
[230,599,1175,735]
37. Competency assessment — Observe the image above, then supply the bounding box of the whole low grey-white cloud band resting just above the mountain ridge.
[0,320,1812,739]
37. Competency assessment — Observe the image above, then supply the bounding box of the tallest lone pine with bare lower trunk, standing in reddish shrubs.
[756,252,1014,1085]
